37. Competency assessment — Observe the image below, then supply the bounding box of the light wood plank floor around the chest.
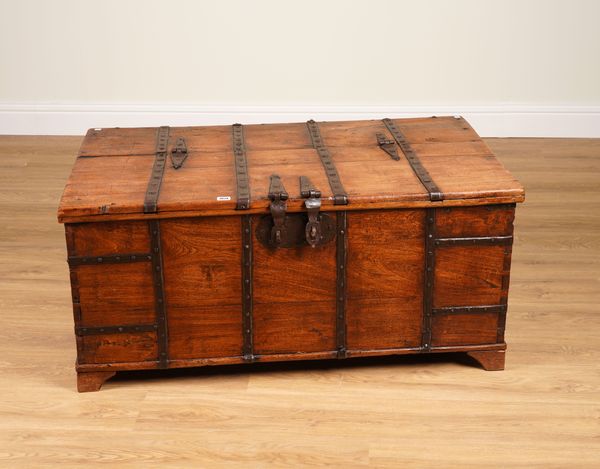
[0,137,600,468]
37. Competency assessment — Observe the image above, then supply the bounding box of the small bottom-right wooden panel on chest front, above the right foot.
[431,313,498,347]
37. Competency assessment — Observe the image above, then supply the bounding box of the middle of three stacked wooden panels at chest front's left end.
[74,262,155,326]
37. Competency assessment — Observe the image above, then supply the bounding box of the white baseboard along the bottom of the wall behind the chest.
[0,103,600,138]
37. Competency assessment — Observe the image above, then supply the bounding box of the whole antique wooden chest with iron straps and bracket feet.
[58,117,524,391]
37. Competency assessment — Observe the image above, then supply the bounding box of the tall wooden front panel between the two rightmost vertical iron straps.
[346,210,425,349]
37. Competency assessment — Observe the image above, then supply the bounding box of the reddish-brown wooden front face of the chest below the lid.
[66,205,514,367]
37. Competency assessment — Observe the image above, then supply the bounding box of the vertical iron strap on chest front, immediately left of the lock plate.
[242,215,254,361]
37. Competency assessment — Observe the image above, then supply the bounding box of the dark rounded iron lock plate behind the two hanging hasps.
[256,212,335,249]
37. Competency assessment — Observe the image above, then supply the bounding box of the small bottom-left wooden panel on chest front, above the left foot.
[77,332,158,365]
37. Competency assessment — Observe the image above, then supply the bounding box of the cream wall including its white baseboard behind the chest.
[0,0,600,136]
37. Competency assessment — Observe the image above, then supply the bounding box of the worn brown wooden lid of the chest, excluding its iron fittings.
[58,117,524,222]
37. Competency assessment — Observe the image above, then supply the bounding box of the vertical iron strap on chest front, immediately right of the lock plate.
[335,211,348,358]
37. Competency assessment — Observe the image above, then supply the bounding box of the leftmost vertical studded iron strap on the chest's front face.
[148,220,169,368]
